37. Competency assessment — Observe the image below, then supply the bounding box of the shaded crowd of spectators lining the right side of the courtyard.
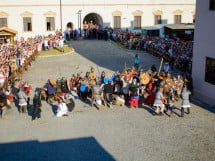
[111,30,193,73]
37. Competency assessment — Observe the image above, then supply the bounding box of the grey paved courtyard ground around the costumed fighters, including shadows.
[0,40,215,161]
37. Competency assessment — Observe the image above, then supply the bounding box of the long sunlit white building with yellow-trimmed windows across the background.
[0,0,195,37]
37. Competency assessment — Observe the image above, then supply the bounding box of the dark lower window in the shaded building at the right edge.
[205,57,215,85]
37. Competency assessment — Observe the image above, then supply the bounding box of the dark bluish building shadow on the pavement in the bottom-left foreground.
[0,137,115,161]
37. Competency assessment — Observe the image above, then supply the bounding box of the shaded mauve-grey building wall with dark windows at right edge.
[192,0,215,105]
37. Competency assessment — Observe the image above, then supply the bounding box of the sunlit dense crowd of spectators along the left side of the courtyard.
[0,30,62,85]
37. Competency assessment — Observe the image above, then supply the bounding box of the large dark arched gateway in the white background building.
[83,13,103,27]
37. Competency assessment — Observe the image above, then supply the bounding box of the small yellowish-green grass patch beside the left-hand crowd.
[39,45,72,56]
